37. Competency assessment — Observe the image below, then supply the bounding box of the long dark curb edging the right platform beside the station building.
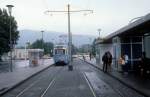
[80,59,150,97]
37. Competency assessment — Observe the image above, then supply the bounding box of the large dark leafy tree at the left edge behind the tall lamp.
[0,9,19,59]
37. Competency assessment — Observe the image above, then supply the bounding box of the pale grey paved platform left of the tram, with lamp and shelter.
[0,59,53,93]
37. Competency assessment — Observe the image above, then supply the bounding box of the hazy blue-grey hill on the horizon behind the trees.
[17,30,95,47]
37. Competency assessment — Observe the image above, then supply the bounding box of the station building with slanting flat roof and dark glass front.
[96,14,150,71]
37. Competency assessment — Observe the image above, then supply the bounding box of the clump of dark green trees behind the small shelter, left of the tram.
[30,39,54,55]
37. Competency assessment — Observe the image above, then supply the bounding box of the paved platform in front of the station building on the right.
[82,57,150,97]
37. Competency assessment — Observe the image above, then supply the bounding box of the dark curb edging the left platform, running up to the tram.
[0,64,54,96]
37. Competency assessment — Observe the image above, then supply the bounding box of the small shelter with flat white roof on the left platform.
[28,49,44,67]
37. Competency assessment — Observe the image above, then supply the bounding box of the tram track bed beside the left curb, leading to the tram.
[1,66,64,97]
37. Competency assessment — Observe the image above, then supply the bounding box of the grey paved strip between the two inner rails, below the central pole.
[40,62,97,97]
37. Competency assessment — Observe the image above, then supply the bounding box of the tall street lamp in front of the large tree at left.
[6,5,14,72]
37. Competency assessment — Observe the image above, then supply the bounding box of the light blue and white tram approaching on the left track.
[53,45,69,65]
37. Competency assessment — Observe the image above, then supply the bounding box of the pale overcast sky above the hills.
[0,0,150,36]
